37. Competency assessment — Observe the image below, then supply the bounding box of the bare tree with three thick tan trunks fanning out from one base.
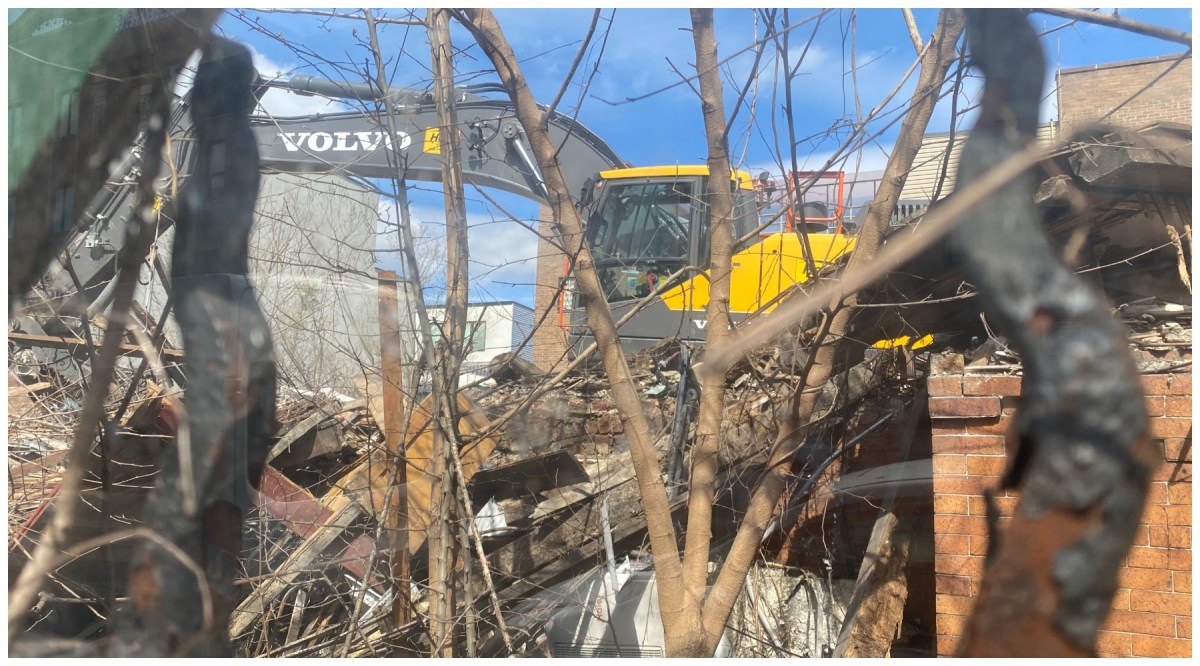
[453,10,962,656]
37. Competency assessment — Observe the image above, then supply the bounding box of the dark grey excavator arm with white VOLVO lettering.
[48,76,625,314]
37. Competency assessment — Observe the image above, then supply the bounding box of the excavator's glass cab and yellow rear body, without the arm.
[559,166,854,353]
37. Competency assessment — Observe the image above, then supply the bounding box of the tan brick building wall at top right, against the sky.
[1058,55,1192,132]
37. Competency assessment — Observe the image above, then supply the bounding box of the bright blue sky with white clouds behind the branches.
[208,8,1193,305]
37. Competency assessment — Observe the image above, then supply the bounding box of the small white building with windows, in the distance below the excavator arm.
[430,301,533,383]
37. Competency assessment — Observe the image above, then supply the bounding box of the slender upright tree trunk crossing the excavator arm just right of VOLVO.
[426,8,470,656]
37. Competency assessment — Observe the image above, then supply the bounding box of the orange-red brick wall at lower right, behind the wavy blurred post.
[929,374,1192,656]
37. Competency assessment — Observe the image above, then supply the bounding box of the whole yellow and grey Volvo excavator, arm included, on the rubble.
[23,69,854,352]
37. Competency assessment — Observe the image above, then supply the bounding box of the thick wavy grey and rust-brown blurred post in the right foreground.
[950,10,1158,658]
